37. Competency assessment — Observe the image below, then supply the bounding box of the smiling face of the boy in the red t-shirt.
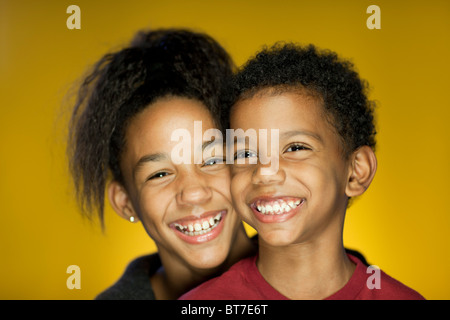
[230,92,351,246]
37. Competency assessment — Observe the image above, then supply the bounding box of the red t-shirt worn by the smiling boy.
[180,255,424,300]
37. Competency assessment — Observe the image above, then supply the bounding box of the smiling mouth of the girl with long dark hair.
[169,210,227,244]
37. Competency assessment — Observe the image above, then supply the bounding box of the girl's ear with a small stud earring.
[108,181,139,222]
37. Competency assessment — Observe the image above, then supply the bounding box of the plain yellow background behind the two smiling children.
[0,0,450,299]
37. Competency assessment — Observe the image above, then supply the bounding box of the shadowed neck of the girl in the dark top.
[150,226,256,300]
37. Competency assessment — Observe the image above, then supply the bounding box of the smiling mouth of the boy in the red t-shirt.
[249,197,306,223]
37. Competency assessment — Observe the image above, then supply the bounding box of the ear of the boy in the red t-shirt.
[345,146,377,198]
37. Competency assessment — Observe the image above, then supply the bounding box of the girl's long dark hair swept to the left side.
[67,29,234,226]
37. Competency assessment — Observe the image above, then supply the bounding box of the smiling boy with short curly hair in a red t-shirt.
[178,44,423,299]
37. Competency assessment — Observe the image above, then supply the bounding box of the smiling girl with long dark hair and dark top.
[68,29,255,299]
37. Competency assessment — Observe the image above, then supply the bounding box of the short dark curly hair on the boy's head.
[222,43,376,156]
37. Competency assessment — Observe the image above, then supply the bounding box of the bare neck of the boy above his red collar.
[257,232,355,300]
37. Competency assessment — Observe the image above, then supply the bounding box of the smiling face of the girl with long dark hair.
[116,97,241,269]
